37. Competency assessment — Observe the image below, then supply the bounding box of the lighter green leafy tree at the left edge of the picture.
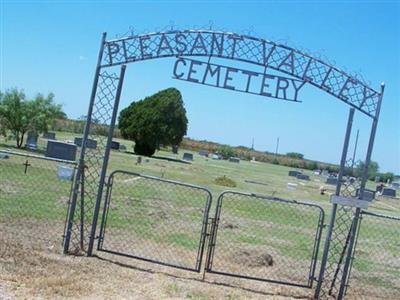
[0,89,65,148]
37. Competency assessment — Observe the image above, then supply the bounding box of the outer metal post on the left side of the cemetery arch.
[64,32,107,254]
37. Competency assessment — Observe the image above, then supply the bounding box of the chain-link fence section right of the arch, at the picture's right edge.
[347,211,400,299]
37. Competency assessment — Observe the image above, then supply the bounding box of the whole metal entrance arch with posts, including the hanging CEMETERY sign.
[64,30,384,298]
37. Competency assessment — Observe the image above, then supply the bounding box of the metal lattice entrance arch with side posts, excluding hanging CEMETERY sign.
[64,30,384,298]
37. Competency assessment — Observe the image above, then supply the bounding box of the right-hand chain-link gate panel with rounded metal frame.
[206,191,324,288]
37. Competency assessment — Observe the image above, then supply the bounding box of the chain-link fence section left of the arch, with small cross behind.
[0,150,75,252]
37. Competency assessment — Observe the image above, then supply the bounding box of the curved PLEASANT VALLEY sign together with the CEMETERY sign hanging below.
[101,30,380,118]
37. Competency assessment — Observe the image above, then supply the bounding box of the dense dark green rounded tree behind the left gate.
[118,88,188,156]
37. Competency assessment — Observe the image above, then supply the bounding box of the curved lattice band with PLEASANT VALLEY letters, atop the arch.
[101,30,380,118]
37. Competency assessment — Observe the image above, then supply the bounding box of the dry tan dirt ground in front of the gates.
[0,236,310,300]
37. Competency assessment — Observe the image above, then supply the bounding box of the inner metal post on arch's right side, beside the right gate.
[314,108,355,299]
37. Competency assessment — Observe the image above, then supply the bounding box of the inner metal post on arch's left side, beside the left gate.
[87,65,126,256]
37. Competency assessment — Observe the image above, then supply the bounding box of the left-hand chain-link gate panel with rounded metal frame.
[98,170,212,272]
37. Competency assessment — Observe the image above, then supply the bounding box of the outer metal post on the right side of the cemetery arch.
[338,83,385,299]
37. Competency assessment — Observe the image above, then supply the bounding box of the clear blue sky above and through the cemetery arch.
[0,0,400,174]
